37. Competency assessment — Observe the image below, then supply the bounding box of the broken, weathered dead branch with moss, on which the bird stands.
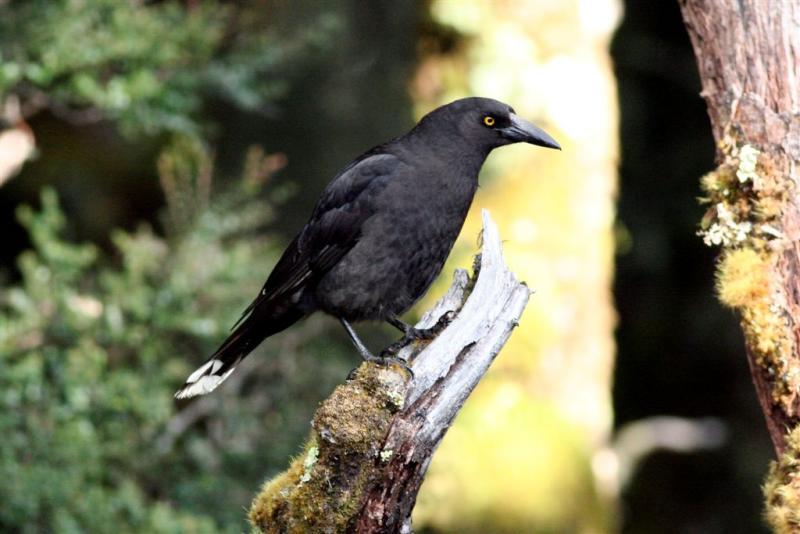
[250,212,530,533]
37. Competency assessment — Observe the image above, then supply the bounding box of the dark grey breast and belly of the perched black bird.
[316,173,477,320]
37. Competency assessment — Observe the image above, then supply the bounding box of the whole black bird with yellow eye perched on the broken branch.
[175,97,561,398]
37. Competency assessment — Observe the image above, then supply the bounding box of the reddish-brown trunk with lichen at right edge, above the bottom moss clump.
[680,0,800,455]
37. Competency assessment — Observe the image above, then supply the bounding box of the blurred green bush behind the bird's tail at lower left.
[0,151,350,532]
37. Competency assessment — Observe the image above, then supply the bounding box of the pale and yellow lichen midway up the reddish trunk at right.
[698,138,800,416]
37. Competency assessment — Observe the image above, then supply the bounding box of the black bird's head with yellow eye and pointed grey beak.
[420,97,561,151]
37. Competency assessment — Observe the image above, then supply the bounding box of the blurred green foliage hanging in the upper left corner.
[0,0,333,134]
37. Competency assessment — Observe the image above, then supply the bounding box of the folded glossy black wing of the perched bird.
[234,147,402,327]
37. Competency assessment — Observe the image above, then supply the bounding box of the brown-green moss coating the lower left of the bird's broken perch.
[249,363,408,533]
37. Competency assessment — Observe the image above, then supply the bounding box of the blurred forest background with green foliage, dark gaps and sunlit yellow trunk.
[0,0,772,533]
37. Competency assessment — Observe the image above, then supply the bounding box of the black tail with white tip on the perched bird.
[175,308,306,399]
